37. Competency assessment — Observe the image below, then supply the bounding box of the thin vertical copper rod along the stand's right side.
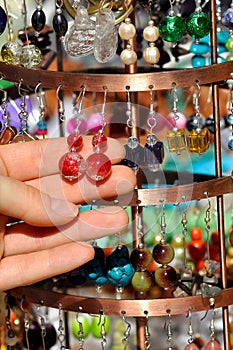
[211,0,230,350]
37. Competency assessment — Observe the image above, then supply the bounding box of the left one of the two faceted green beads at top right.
[159,15,185,43]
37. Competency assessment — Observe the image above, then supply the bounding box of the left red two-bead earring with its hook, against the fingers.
[57,85,86,181]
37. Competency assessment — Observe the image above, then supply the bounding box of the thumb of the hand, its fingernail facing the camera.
[0,175,78,226]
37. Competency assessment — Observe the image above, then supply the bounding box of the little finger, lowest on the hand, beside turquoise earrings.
[0,242,94,291]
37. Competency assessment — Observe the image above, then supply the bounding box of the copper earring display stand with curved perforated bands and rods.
[0,0,233,350]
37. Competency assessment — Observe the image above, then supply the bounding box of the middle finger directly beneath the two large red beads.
[28,165,136,203]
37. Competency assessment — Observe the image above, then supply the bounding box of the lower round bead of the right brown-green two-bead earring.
[154,265,177,289]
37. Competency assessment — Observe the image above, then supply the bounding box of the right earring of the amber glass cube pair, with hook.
[188,81,210,154]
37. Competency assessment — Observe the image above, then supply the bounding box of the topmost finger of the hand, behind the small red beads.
[0,136,124,180]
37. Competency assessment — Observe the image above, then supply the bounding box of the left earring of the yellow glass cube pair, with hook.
[167,83,186,155]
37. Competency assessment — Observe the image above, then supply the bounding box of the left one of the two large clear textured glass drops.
[64,6,96,57]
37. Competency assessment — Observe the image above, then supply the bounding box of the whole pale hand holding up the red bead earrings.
[0,136,136,291]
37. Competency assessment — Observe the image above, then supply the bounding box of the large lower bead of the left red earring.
[59,152,86,181]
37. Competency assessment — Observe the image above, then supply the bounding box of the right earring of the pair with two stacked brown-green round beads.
[152,200,177,289]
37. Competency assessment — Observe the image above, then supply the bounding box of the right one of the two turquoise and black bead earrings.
[106,234,135,294]
